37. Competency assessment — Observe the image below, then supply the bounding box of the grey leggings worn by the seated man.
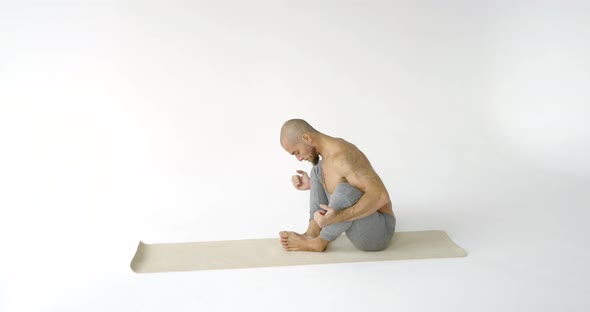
[309,161,395,251]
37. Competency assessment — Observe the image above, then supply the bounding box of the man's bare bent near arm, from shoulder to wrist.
[335,152,390,223]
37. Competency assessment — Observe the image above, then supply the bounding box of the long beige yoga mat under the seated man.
[131,231,467,273]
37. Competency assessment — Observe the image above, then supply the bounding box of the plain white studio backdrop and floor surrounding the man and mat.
[0,0,590,311]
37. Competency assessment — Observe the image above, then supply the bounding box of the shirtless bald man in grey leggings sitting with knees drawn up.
[279,119,396,251]
